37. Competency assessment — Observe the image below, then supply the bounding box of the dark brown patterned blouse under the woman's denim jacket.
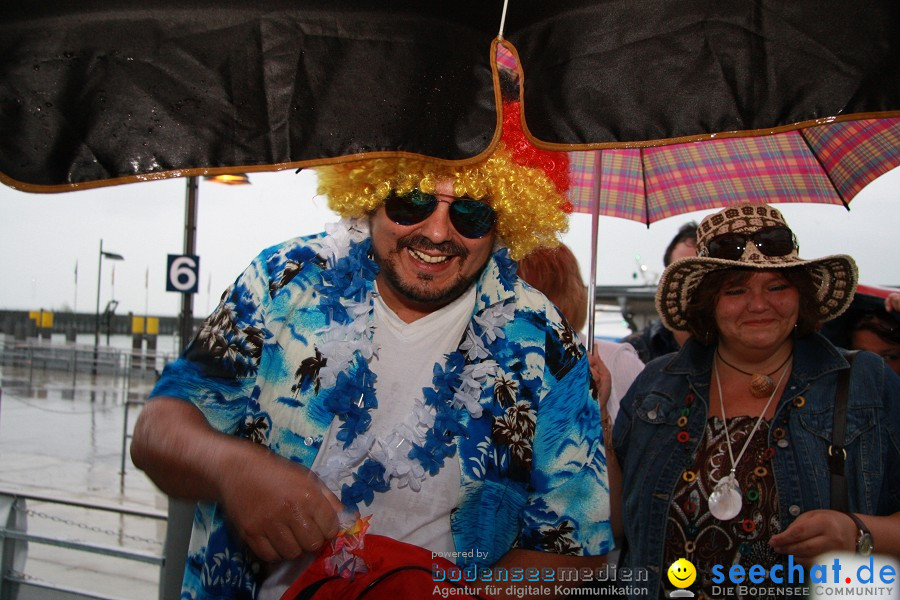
[663,416,781,597]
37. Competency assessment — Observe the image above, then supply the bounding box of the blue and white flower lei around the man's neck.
[316,219,515,509]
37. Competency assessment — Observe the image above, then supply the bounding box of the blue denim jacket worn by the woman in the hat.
[613,334,900,597]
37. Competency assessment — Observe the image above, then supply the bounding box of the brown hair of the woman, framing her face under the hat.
[684,266,819,346]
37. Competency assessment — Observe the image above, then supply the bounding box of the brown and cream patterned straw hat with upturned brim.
[656,204,858,330]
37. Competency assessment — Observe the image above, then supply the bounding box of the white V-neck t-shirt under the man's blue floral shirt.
[259,286,475,600]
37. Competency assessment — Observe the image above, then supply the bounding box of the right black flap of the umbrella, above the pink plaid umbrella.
[506,0,900,150]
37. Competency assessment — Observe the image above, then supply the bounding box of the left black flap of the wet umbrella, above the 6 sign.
[0,0,500,191]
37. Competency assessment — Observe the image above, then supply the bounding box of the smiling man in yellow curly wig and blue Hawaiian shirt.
[132,101,612,599]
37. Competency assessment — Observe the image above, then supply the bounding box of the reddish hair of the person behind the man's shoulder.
[518,244,587,331]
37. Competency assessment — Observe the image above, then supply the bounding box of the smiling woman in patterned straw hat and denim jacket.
[613,204,900,595]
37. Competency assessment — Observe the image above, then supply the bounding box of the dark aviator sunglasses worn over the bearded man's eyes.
[384,189,497,240]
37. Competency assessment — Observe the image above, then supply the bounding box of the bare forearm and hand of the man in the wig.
[131,396,343,561]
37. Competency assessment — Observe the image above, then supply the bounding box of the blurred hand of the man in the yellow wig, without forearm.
[221,452,344,562]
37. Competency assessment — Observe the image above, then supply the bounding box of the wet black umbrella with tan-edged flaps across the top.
[0,0,900,191]
